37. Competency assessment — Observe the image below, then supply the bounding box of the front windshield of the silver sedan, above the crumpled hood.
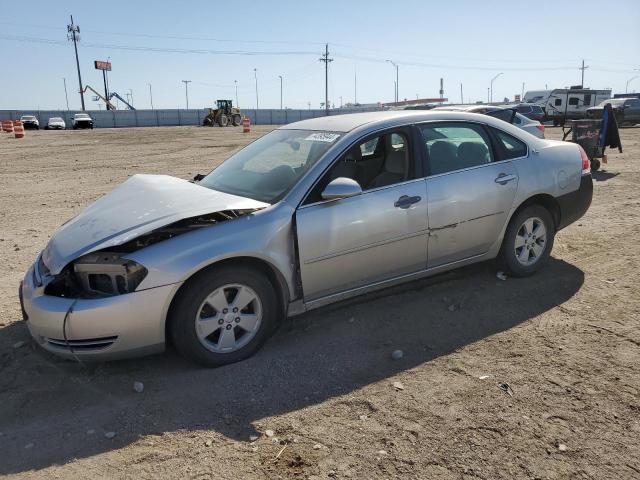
[200,130,340,203]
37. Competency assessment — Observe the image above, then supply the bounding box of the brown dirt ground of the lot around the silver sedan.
[0,127,640,479]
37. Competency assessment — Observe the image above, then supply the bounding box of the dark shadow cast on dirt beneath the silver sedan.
[0,258,584,475]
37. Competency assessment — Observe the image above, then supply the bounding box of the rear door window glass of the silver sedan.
[420,123,493,175]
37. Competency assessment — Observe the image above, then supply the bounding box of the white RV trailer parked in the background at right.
[524,86,611,125]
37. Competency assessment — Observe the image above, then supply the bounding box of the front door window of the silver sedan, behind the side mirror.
[305,131,415,204]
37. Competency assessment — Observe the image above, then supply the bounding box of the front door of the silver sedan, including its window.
[296,130,427,302]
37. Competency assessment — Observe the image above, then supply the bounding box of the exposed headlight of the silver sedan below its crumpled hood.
[73,252,147,295]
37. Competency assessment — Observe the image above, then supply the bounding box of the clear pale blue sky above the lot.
[0,0,640,110]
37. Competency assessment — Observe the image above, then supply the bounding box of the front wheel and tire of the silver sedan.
[169,266,280,367]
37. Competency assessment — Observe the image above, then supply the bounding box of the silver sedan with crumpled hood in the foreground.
[19,110,593,366]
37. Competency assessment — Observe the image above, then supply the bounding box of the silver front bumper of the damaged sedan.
[20,264,180,361]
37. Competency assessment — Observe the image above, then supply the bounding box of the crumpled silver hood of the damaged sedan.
[42,175,269,275]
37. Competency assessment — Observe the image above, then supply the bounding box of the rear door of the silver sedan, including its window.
[419,122,526,268]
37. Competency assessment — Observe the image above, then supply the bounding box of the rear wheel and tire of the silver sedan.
[500,205,555,277]
